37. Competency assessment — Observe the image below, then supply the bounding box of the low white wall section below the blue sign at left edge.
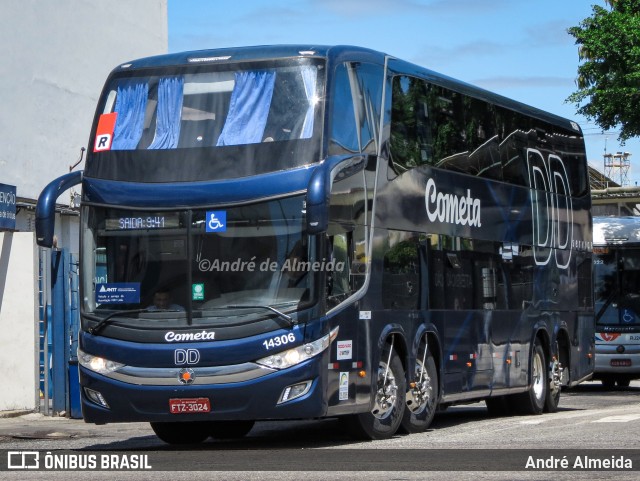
[0,232,39,411]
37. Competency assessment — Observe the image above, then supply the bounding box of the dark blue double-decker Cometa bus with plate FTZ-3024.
[37,45,594,443]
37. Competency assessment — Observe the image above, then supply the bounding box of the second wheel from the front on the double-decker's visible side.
[400,351,439,434]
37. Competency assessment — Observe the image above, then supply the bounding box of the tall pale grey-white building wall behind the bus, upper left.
[0,0,168,201]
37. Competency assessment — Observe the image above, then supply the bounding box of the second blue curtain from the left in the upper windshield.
[148,77,184,149]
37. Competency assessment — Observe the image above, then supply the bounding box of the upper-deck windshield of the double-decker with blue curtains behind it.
[85,58,324,182]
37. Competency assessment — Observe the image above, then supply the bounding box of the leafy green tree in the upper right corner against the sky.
[567,0,640,144]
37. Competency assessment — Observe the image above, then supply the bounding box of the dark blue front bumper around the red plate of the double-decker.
[80,351,329,424]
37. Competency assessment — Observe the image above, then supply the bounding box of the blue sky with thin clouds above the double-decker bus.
[168,0,640,184]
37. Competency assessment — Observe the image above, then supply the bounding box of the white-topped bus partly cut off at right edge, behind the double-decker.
[593,216,640,388]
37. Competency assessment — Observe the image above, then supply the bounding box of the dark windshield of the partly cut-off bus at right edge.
[594,247,640,327]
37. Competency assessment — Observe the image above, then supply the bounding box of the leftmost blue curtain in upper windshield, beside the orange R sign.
[111,80,149,150]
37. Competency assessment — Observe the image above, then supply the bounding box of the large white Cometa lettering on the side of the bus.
[424,179,482,227]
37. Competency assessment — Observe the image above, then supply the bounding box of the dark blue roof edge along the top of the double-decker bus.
[112,44,582,136]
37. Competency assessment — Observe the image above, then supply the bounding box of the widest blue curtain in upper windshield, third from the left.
[216,72,276,146]
